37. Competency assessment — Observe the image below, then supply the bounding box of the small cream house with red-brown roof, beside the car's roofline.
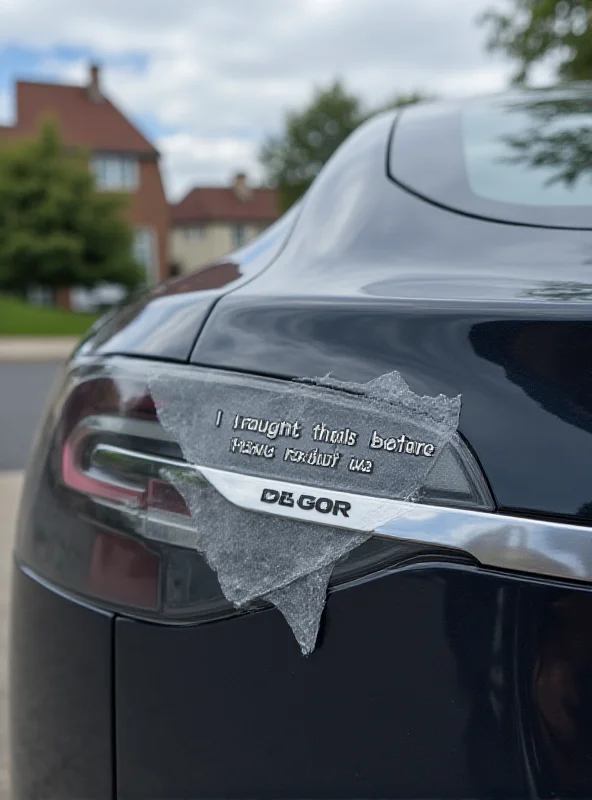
[169,173,280,273]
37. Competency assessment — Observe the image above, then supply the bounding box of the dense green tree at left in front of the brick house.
[0,121,143,300]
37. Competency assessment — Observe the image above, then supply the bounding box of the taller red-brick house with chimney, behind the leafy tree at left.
[0,65,168,296]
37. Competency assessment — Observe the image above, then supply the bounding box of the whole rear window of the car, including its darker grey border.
[389,89,592,229]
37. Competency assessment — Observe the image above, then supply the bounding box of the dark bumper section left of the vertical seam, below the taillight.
[10,567,114,800]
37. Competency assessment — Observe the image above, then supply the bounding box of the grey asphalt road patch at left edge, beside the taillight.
[0,362,60,471]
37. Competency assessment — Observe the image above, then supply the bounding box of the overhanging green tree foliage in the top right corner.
[479,0,592,83]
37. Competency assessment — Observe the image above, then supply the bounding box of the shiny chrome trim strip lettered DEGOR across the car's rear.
[88,445,592,582]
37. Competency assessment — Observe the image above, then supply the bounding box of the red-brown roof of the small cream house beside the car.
[171,187,280,226]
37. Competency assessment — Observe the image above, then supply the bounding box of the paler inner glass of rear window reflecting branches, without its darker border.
[463,97,592,206]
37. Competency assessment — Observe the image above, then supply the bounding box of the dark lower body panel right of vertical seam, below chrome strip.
[115,564,592,798]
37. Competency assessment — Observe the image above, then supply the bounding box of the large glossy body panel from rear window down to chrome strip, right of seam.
[192,116,592,519]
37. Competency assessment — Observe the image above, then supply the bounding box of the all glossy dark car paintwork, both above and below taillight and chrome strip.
[11,89,592,800]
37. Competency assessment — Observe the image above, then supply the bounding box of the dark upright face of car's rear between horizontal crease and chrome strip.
[195,298,592,520]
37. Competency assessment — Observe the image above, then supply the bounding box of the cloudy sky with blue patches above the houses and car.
[0,0,544,200]
